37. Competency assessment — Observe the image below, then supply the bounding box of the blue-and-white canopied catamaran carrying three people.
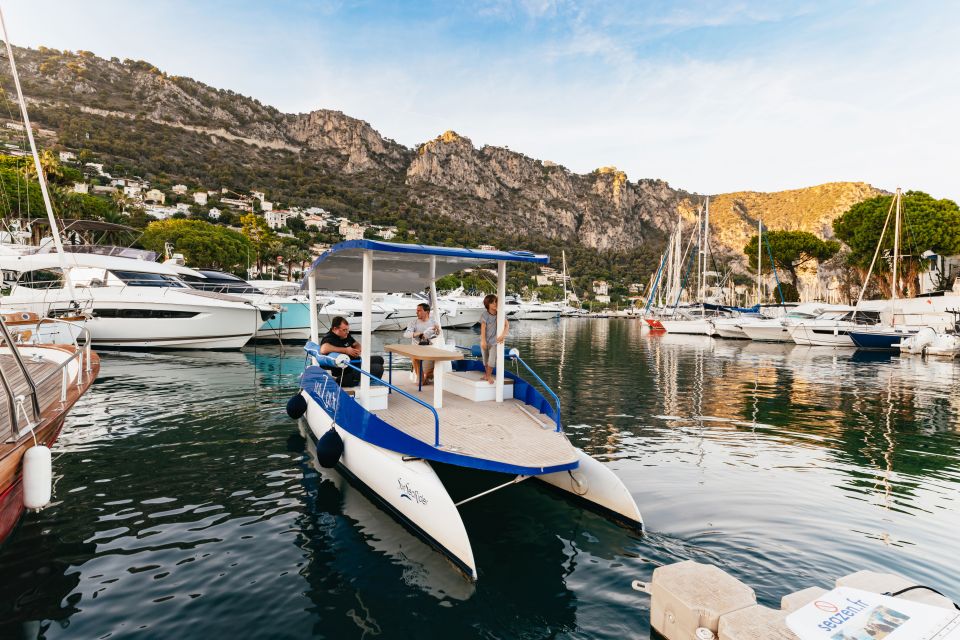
[288,240,643,580]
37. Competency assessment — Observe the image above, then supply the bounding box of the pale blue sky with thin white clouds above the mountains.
[3,0,960,199]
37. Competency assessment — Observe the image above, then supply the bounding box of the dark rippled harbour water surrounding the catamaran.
[0,319,960,639]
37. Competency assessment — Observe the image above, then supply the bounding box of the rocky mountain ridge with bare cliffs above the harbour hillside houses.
[0,43,877,268]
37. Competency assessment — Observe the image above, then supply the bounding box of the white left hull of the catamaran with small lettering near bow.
[304,394,477,580]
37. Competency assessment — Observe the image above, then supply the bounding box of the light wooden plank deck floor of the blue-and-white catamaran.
[376,372,577,468]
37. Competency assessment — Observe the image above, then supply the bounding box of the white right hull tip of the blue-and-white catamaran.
[534,449,643,529]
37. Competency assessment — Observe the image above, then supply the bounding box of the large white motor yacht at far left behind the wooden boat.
[0,253,265,349]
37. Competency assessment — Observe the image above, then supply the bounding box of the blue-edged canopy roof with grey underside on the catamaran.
[301,240,550,291]
